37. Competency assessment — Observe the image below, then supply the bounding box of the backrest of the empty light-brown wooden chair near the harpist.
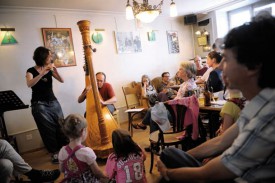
[122,86,142,109]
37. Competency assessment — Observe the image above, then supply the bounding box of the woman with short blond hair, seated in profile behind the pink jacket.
[133,61,197,133]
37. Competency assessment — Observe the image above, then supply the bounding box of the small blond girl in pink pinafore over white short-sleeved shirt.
[58,114,108,183]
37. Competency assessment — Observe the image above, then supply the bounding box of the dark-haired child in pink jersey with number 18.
[106,129,147,183]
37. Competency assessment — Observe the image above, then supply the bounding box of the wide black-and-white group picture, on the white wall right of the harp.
[115,32,142,53]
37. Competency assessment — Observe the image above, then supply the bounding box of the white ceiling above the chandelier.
[0,0,247,16]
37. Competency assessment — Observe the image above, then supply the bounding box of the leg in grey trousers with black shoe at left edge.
[0,139,60,183]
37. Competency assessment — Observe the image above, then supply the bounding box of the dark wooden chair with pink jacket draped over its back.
[149,101,206,173]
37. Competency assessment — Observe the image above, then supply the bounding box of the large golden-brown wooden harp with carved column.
[77,20,118,158]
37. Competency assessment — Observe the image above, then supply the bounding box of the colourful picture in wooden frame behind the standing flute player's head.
[42,28,76,67]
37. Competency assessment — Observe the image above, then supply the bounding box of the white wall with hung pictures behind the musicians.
[0,7,194,140]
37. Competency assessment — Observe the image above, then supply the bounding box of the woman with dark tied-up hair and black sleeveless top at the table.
[207,51,224,93]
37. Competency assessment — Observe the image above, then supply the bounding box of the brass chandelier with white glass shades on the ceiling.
[126,0,177,23]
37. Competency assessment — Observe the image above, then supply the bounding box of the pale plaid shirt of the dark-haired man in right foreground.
[222,88,275,183]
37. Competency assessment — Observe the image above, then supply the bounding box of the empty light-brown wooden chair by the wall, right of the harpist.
[122,86,149,136]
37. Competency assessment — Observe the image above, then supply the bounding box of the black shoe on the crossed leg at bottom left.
[26,169,60,182]
